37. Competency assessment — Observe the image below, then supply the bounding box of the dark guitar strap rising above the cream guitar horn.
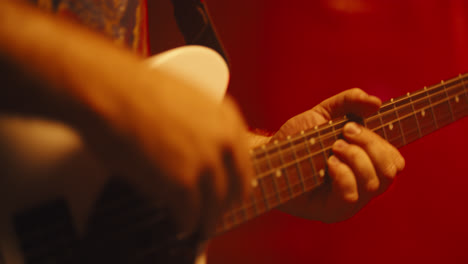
[171,0,229,65]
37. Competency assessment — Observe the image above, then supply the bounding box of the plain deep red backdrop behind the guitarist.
[149,0,468,264]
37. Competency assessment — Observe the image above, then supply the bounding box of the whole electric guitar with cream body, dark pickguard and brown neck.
[0,46,468,264]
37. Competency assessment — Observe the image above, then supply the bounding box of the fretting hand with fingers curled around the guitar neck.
[273,88,405,223]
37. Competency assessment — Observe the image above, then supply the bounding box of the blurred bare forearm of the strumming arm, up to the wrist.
[0,0,146,128]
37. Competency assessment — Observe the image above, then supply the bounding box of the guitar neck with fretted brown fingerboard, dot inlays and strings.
[216,74,468,234]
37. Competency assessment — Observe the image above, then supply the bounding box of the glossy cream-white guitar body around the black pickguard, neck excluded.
[0,46,229,264]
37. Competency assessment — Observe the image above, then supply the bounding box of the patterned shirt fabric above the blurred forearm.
[30,0,148,56]
